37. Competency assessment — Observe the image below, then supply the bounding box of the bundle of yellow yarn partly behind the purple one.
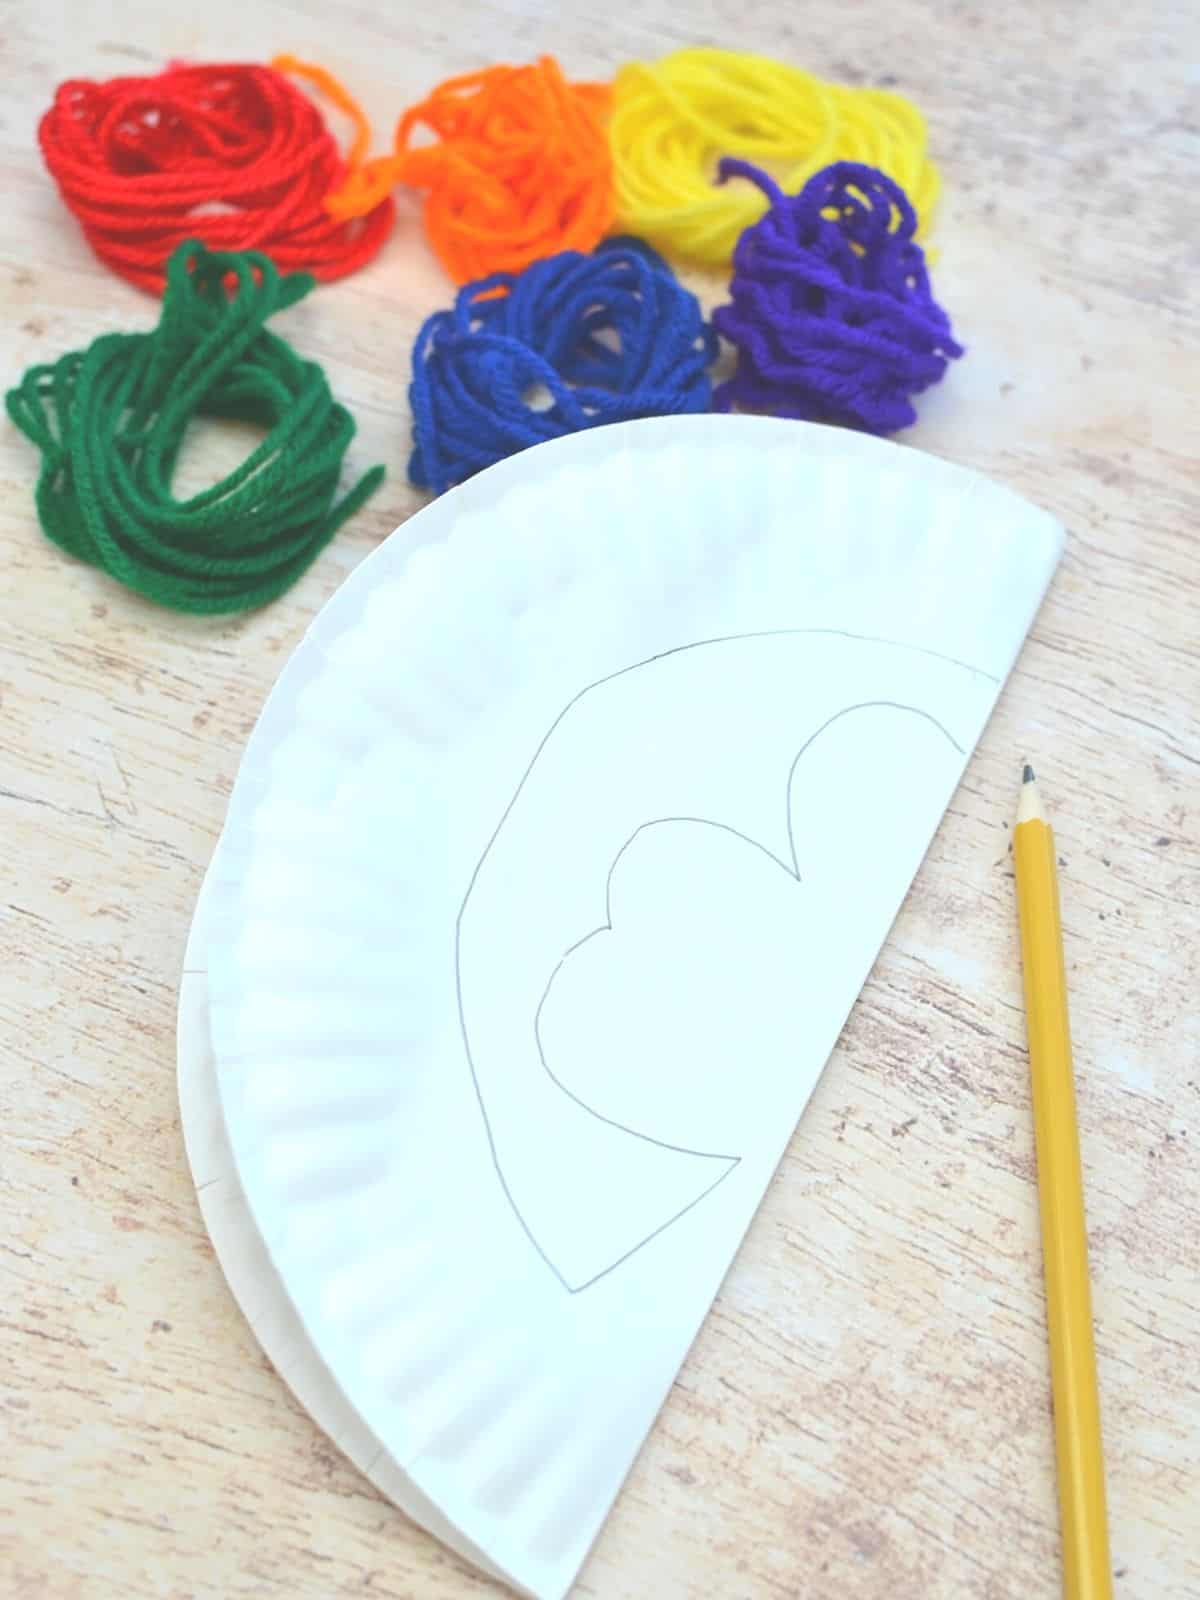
[610,50,941,267]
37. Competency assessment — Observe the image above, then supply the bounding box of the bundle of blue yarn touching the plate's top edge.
[408,238,717,494]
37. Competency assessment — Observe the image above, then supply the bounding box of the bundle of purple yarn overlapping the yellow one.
[712,160,963,434]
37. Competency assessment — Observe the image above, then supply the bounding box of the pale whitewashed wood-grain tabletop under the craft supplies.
[0,0,1200,1600]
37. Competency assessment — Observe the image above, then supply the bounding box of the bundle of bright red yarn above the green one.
[38,66,395,294]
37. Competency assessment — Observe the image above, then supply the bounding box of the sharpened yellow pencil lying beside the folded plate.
[1013,766,1112,1600]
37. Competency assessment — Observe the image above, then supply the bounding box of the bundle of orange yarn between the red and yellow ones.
[312,56,614,283]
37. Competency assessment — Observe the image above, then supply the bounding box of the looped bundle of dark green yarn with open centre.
[6,240,384,613]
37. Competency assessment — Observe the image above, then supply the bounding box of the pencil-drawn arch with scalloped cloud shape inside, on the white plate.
[456,630,995,1294]
